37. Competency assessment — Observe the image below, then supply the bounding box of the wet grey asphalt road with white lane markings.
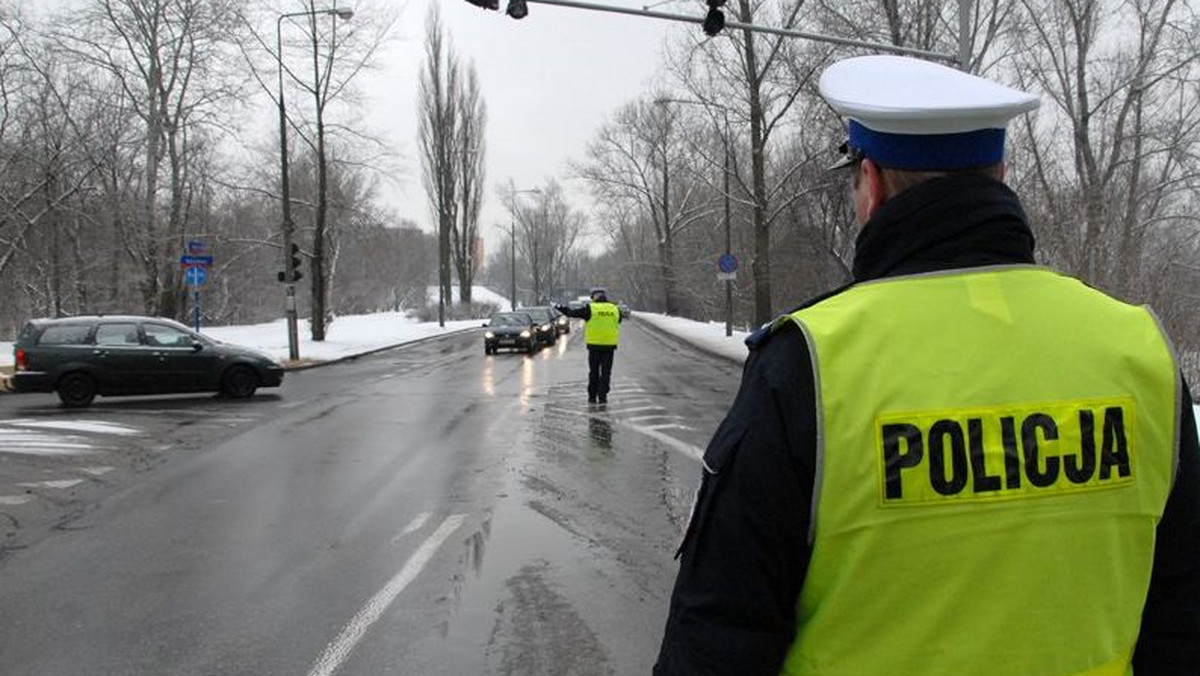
[0,322,739,676]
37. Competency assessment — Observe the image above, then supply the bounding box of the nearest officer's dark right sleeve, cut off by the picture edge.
[1133,384,1200,676]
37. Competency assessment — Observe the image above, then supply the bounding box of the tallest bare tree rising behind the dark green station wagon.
[56,0,236,316]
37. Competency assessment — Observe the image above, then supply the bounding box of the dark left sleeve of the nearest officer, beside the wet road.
[654,330,816,676]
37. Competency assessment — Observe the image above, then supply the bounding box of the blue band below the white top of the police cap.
[847,120,1004,169]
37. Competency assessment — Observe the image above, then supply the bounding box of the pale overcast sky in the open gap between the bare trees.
[360,0,701,251]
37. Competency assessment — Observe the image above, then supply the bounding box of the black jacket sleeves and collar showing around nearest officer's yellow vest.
[654,177,1200,676]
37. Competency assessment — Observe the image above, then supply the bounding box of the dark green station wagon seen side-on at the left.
[12,316,283,407]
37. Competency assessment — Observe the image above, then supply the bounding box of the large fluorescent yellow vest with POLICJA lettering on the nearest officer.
[780,265,1180,676]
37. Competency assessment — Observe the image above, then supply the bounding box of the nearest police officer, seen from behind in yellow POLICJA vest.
[654,56,1200,676]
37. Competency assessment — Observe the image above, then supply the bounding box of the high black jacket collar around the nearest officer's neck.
[853,174,1033,282]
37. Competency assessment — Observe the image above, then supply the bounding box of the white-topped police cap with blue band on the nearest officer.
[820,55,1039,169]
